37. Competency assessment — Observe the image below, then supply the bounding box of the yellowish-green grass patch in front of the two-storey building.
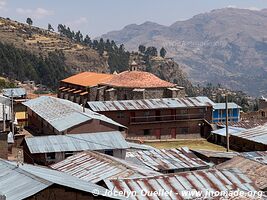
[145,139,226,151]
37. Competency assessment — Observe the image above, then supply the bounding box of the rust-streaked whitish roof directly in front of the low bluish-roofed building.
[51,152,160,183]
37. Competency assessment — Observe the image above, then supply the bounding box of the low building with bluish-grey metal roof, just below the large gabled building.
[23,131,129,165]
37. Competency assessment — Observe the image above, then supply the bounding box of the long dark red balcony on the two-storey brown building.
[130,114,206,124]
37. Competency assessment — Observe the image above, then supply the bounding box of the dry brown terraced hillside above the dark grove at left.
[0,18,109,72]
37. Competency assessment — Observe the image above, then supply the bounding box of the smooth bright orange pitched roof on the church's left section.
[62,72,114,87]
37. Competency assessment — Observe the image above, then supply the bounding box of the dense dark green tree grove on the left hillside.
[0,43,70,89]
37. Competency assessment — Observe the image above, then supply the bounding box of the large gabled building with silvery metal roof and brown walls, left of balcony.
[23,96,126,135]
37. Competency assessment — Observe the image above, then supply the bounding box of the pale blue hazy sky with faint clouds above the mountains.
[0,0,267,38]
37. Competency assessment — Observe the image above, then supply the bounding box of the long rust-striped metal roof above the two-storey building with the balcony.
[88,97,215,112]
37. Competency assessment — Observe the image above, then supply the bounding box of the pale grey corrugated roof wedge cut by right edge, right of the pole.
[232,125,267,145]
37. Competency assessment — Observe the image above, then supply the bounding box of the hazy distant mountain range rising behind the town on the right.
[102,8,267,95]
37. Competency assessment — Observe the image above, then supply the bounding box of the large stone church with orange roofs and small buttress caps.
[58,70,185,104]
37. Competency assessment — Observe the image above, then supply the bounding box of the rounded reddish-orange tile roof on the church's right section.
[102,71,175,88]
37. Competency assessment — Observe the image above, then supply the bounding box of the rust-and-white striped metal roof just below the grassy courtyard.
[126,148,209,172]
